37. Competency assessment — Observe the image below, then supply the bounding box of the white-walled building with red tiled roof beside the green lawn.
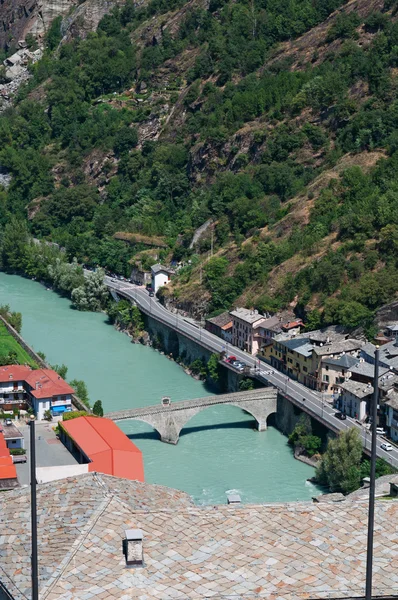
[0,365,74,420]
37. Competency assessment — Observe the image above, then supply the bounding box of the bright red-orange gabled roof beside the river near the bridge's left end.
[62,417,144,481]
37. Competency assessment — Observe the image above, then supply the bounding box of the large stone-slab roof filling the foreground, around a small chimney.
[0,474,398,600]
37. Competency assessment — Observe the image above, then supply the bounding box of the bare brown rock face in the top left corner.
[0,0,78,48]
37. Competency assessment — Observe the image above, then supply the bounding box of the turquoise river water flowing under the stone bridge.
[0,273,317,504]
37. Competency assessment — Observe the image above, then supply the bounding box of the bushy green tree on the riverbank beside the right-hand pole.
[316,427,362,494]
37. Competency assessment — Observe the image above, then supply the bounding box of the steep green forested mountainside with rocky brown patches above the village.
[0,0,398,327]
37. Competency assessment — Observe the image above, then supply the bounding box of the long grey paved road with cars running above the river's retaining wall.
[105,277,398,468]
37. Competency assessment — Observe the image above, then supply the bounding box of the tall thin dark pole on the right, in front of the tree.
[365,346,379,600]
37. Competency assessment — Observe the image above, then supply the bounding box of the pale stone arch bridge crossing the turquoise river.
[105,387,277,444]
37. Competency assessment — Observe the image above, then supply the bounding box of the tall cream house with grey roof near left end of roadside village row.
[230,308,266,355]
